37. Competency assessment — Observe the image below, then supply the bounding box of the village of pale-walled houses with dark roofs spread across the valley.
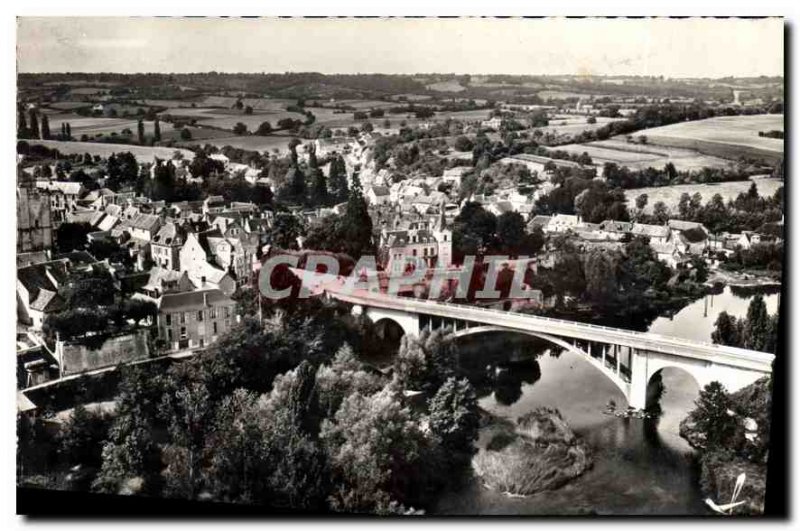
[17,83,782,404]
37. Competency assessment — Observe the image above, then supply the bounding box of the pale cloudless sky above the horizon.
[17,17,784,78]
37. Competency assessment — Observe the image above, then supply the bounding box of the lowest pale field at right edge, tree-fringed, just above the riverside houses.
[625,176,783,214]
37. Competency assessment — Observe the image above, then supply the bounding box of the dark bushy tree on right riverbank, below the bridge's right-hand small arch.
[690,381,736,450]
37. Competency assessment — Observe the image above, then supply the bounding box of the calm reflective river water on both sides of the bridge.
[433,287,778,515]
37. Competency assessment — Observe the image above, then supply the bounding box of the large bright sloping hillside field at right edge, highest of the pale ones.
[636,114,783,161]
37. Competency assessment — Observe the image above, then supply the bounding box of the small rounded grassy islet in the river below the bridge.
[472,408,592,496]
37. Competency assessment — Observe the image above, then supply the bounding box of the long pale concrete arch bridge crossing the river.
[324,284,775,409]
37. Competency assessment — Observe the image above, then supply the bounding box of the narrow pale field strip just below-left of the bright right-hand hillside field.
[554,139,731,171]
